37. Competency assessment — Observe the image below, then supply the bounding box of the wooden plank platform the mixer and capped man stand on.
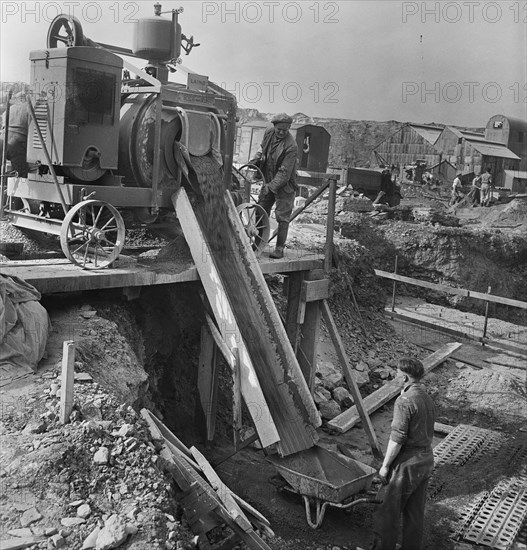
[0,253,324,294]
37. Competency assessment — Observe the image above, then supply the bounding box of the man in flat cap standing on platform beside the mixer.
[249,113,298,258]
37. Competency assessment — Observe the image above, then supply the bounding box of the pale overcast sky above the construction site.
[0,0,527,126]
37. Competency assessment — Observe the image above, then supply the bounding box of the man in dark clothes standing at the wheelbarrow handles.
[373,358,435,550]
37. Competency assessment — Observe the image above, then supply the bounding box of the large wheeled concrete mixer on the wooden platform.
[6,4,269,269]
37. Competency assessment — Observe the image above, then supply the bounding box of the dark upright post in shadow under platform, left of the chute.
[198,325,218,441]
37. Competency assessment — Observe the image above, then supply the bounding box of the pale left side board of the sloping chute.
[173,192,280,447]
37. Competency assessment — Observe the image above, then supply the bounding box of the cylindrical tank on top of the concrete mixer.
[132,17,181,61]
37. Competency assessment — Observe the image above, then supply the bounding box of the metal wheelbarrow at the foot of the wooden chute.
[267,446,382,529]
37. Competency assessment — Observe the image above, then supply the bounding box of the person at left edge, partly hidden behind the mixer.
[0,92,29,178]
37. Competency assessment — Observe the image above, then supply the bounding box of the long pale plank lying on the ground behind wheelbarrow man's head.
[328,342,462,433]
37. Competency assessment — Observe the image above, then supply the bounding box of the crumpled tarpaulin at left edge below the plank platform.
[0,274,50,381]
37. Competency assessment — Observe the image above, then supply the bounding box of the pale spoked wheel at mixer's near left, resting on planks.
[60,200,125,269]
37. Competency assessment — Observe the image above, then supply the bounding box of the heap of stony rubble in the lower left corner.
[0,372,193,550]
